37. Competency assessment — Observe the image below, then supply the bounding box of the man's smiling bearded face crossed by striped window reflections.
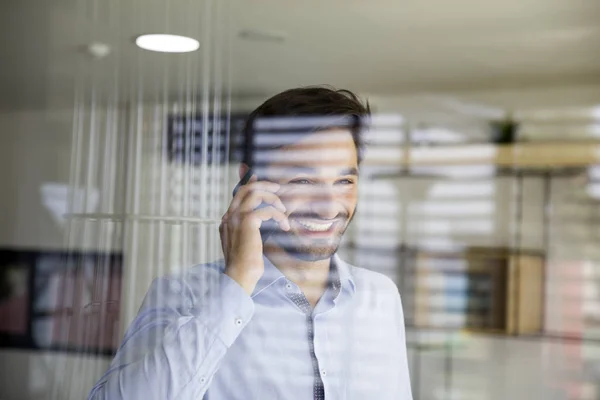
[265,129,358,261]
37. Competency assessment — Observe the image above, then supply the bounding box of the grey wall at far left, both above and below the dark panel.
[0,110,109,400]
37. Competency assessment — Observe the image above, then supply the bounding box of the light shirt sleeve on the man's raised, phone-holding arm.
[88,271,254,400]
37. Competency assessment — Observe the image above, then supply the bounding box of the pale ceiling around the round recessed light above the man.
[0,0,600,114]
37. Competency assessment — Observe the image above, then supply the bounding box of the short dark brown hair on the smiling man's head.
[242,85,371,167]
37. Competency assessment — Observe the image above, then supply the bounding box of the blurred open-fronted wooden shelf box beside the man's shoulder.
[404,248,544,335]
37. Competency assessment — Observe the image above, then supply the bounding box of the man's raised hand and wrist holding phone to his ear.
[219,175,290,295]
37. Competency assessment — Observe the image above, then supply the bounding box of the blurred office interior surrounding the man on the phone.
[0,0,600,400]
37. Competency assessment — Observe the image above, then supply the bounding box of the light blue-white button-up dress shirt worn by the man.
[89,255,412,400]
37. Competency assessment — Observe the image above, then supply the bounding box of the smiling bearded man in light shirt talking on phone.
[90,87,412,400]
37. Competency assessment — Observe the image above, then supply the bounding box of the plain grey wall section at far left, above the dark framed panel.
[0,110,72,248]
